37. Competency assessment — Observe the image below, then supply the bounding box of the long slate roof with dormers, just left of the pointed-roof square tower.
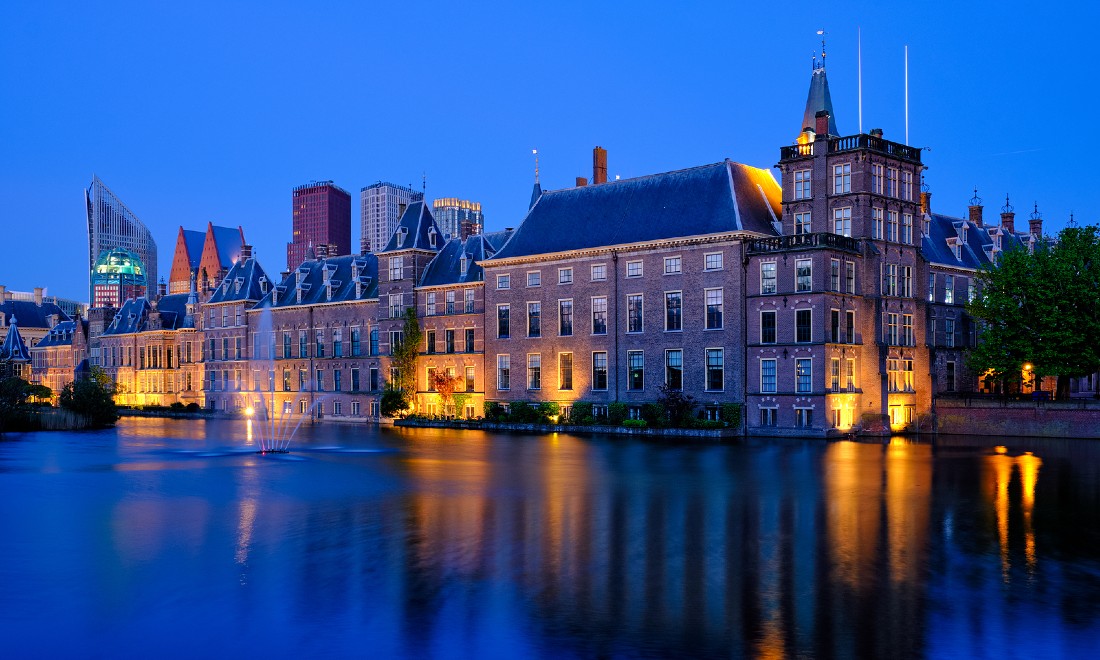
[255,254,378,309]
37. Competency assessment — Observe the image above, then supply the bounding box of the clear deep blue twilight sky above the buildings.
[0,0,1100,299]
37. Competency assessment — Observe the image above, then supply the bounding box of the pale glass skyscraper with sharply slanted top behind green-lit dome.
[84,175,156,300]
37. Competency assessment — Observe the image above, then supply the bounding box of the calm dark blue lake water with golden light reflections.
[0,419,1100,659]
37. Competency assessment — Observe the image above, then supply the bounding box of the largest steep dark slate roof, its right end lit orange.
[493,161,781,259]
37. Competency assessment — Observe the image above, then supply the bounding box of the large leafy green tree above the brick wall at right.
[968,226,1100,398]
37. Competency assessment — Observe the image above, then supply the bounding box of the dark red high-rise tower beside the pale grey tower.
[286,182,351,271]
